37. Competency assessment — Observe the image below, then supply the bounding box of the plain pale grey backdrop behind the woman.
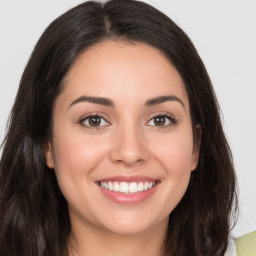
[0,0,256,236]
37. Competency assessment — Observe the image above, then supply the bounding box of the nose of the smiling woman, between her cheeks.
[110,124,149,166]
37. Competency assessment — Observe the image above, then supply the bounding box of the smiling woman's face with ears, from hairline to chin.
[46,41,198,234]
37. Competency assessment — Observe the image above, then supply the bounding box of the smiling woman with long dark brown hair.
[0,0,236,256]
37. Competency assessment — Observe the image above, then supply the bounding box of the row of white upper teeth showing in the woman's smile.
[100,181,156,194]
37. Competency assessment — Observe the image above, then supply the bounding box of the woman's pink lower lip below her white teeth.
[99,183,159,204]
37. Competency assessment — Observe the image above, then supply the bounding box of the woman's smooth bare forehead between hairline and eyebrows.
[59,41,188,107]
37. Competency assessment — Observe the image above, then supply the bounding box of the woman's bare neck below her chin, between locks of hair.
[69,218,167,256]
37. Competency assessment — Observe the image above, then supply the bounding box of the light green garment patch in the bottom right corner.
[236,231,256,256]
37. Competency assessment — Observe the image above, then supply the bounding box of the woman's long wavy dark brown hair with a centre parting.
[0,0,237,256]
